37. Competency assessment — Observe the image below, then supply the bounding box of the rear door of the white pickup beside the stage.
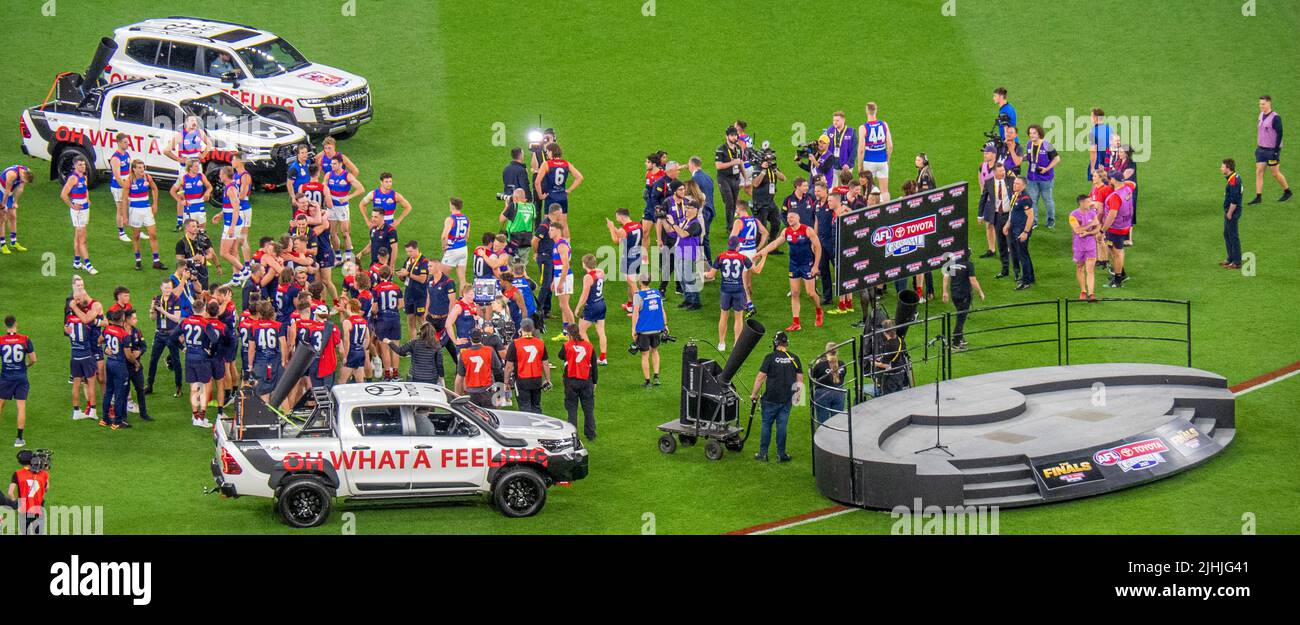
[334,404,411,495]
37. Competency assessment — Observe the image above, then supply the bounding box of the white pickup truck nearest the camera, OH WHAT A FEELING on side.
[212,382,588,528]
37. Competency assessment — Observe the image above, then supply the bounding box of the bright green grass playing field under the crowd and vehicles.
[0,0,1300,534]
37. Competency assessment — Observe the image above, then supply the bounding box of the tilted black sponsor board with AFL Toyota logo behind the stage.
[835,182,969,294]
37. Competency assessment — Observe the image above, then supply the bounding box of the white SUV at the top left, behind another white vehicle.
[104,17,371,136]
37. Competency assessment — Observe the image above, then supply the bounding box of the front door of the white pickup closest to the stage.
[410,405,491,492]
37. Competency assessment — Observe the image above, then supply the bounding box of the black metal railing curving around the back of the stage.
[809,298,1192,483]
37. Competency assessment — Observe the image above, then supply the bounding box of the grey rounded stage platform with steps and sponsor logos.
[813,364,1236,508]
